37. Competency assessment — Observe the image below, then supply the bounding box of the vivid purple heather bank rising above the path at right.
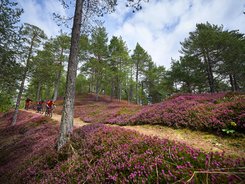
[107,93,245,133]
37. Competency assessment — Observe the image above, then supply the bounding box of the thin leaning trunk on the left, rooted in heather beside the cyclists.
[12,35,36,126]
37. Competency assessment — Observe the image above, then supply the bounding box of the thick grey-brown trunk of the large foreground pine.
[57,0,84,150]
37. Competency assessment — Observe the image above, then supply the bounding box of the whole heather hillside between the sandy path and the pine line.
[56,93,245,135]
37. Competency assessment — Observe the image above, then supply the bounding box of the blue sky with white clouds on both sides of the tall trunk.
[17,0,245,69]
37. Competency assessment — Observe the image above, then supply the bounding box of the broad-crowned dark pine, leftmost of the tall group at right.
[181,22,223,93]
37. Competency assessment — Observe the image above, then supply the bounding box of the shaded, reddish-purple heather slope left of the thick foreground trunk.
[0,111,58,183]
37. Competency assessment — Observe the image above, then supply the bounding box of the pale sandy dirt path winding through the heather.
[23,110,245,157]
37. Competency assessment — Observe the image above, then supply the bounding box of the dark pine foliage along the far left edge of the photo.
[0,0,23,111]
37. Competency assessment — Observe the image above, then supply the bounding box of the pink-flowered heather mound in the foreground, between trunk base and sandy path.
[18,124,245,183]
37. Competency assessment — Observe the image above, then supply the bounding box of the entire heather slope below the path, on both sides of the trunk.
[0,111,245,183]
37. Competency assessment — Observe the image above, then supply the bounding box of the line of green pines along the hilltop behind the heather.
[25,22,245,104]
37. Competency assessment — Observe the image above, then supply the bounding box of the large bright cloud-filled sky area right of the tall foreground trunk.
[106,0,245,68]
